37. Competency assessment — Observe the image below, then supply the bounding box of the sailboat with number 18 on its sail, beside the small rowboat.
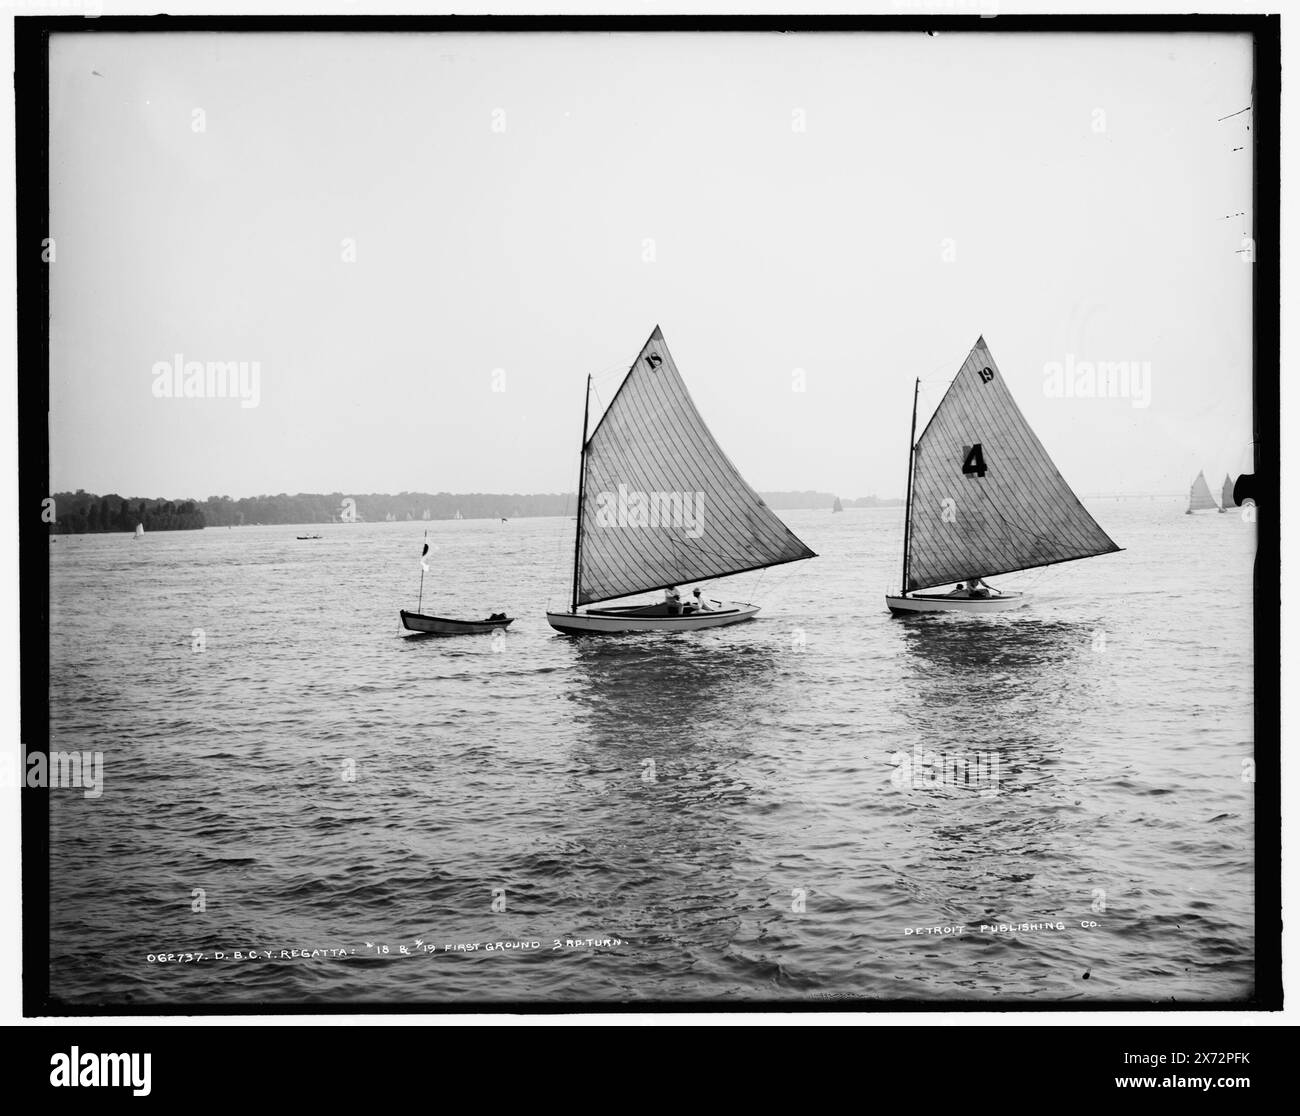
[546,325,816,635]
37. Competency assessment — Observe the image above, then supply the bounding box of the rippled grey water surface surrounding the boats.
[45,499,1255,1005]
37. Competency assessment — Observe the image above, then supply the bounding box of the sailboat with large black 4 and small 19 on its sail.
[885,337,1121,615]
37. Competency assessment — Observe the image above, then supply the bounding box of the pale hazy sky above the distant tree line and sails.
[49,34,1252,497]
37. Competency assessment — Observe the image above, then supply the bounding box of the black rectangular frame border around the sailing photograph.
[14,14,1282,1017]
